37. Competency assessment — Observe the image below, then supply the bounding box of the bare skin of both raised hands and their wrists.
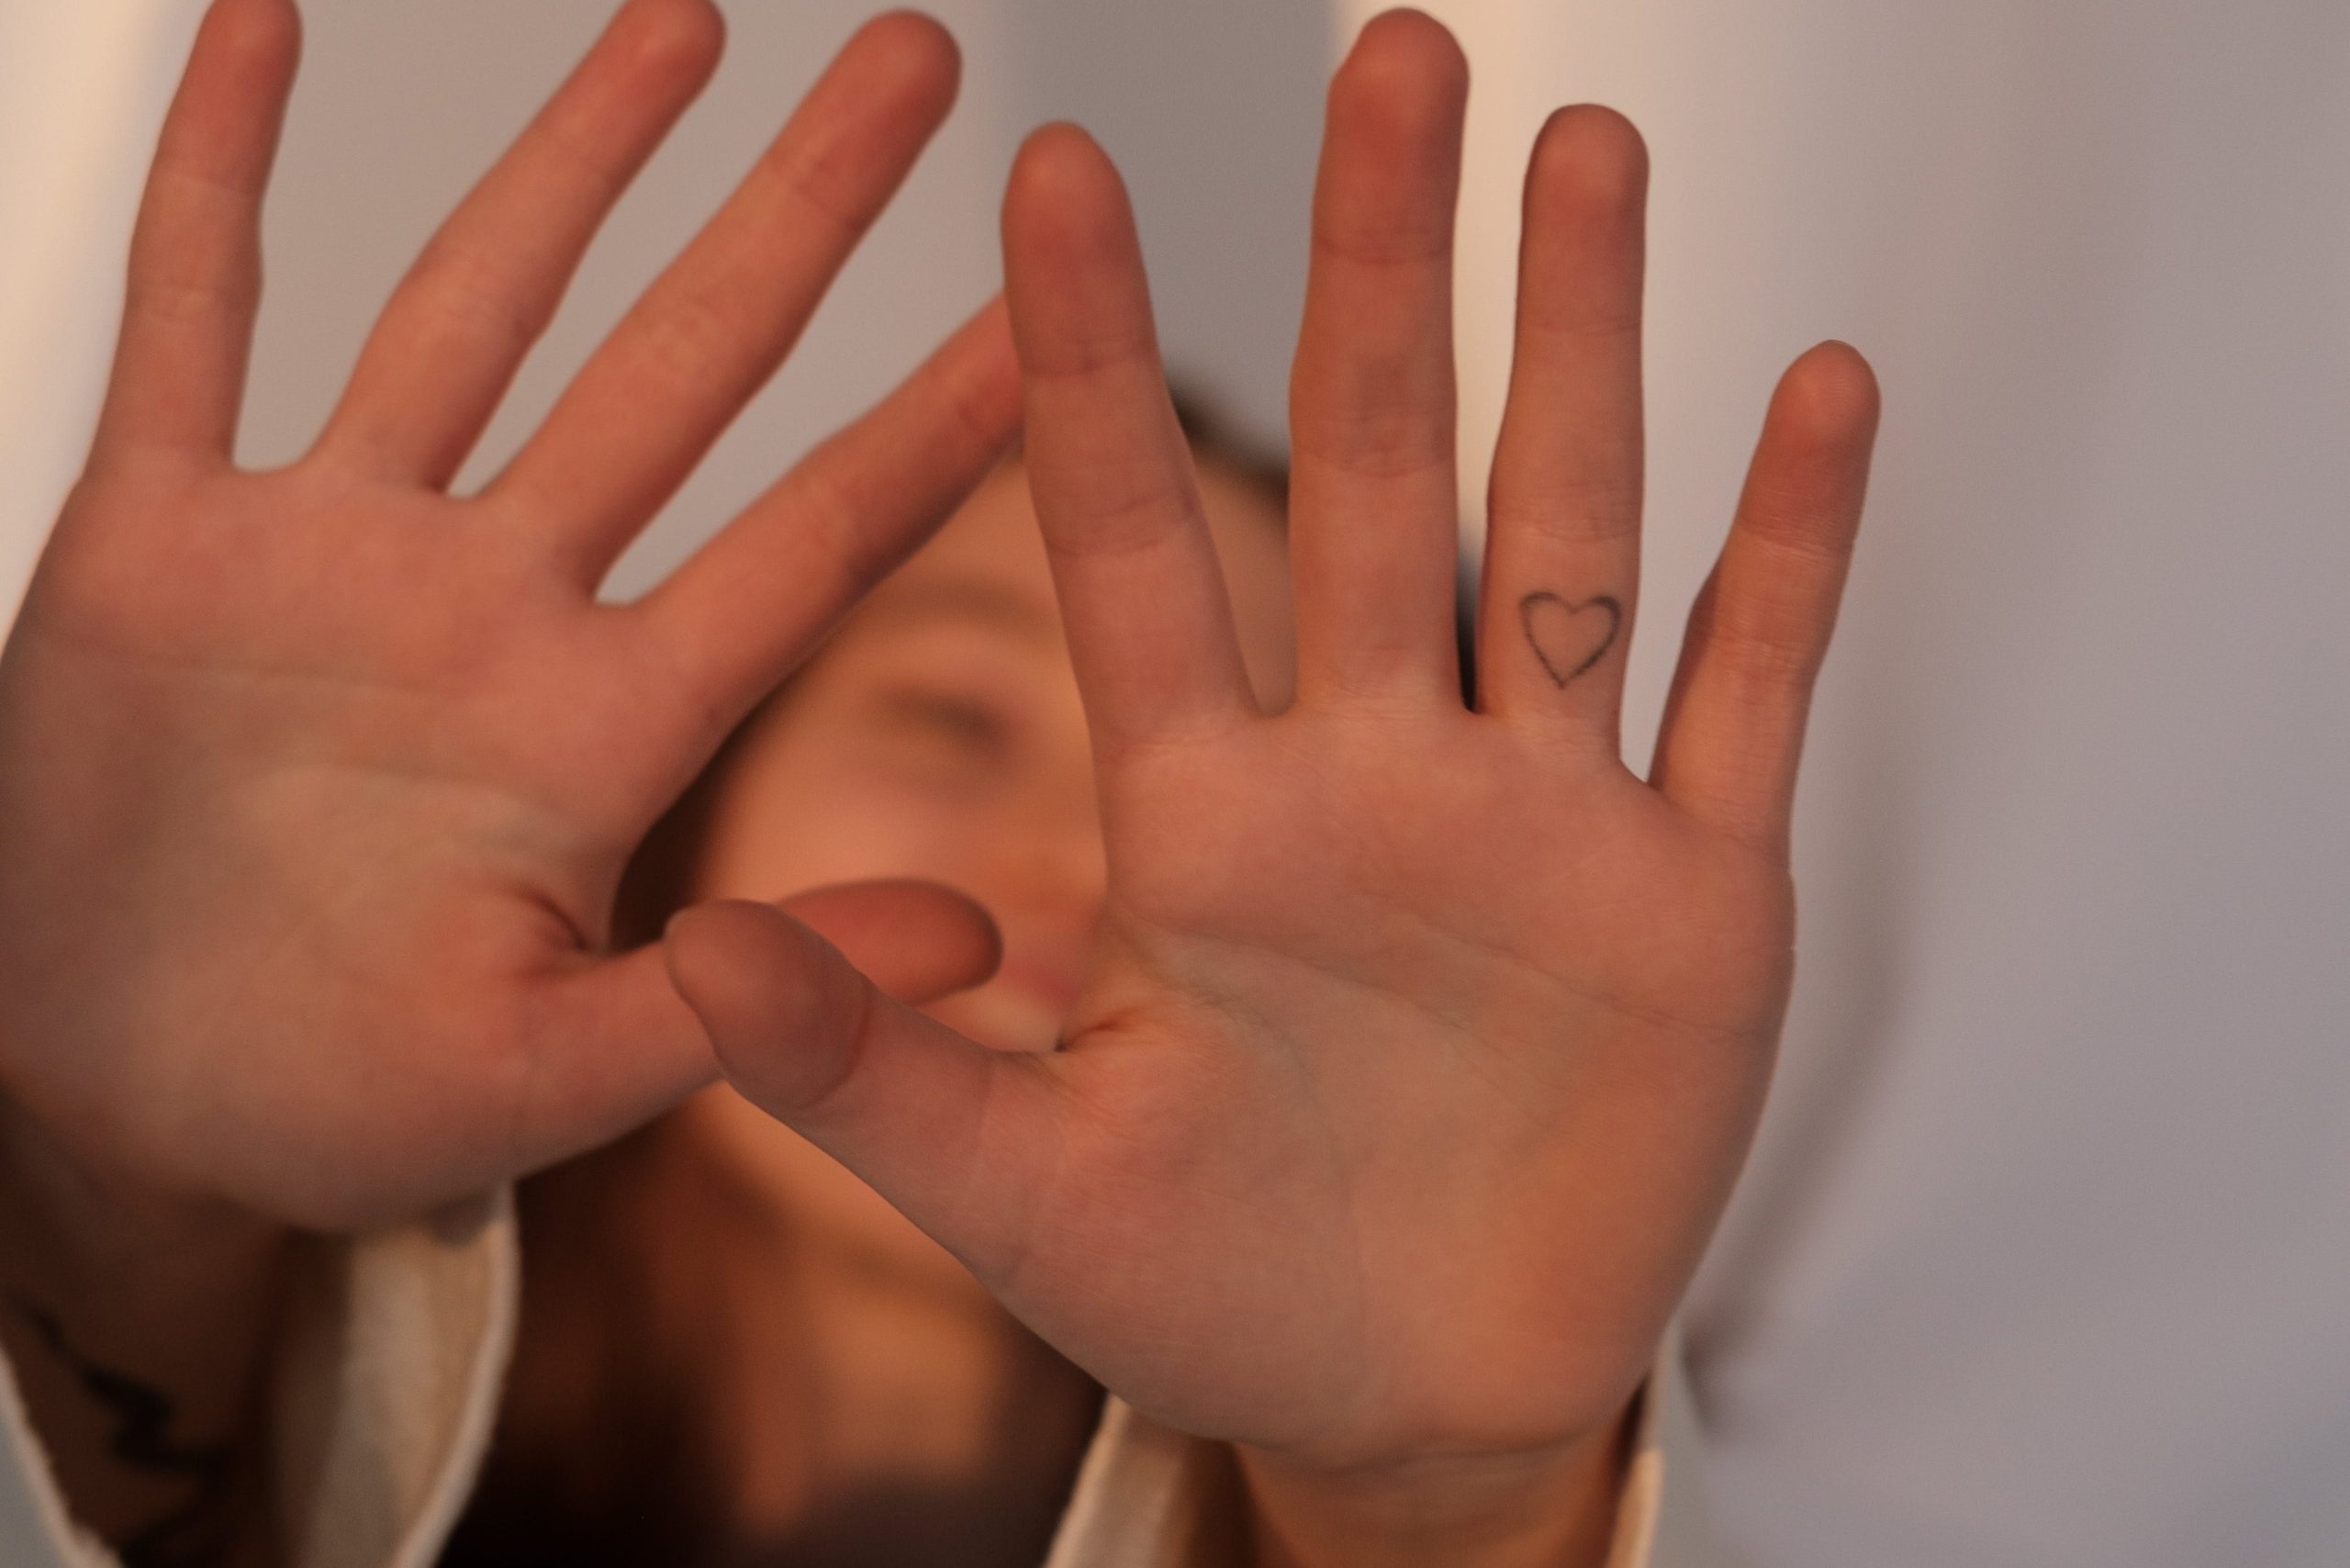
[0,0,1875,1568]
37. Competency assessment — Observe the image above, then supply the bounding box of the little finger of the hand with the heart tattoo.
[1654,343,1877,854]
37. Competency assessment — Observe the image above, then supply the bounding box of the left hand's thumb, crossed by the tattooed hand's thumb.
[517,881,1003,1184]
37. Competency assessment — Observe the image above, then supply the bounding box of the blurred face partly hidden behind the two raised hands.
[672,451,1290,1279]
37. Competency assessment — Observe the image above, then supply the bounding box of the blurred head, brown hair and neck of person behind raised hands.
[444,407,1290,1568]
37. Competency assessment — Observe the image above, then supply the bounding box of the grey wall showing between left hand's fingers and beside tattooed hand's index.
[244,0,1330,595]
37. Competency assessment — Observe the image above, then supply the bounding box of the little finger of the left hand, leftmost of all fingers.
[99,0,301,461]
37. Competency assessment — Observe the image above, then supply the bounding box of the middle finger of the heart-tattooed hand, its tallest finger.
[1290,12,1469,700]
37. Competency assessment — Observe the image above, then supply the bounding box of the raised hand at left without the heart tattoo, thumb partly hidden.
[0,0,1017,1227]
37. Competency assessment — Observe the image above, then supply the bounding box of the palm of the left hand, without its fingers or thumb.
[5,460,672,1215]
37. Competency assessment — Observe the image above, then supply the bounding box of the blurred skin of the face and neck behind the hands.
[615,451,1292,1561]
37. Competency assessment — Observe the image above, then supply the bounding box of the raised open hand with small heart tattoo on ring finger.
[670,14,1875,1561]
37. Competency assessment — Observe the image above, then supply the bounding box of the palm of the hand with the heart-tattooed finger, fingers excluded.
[1006,714,1786,1458]
